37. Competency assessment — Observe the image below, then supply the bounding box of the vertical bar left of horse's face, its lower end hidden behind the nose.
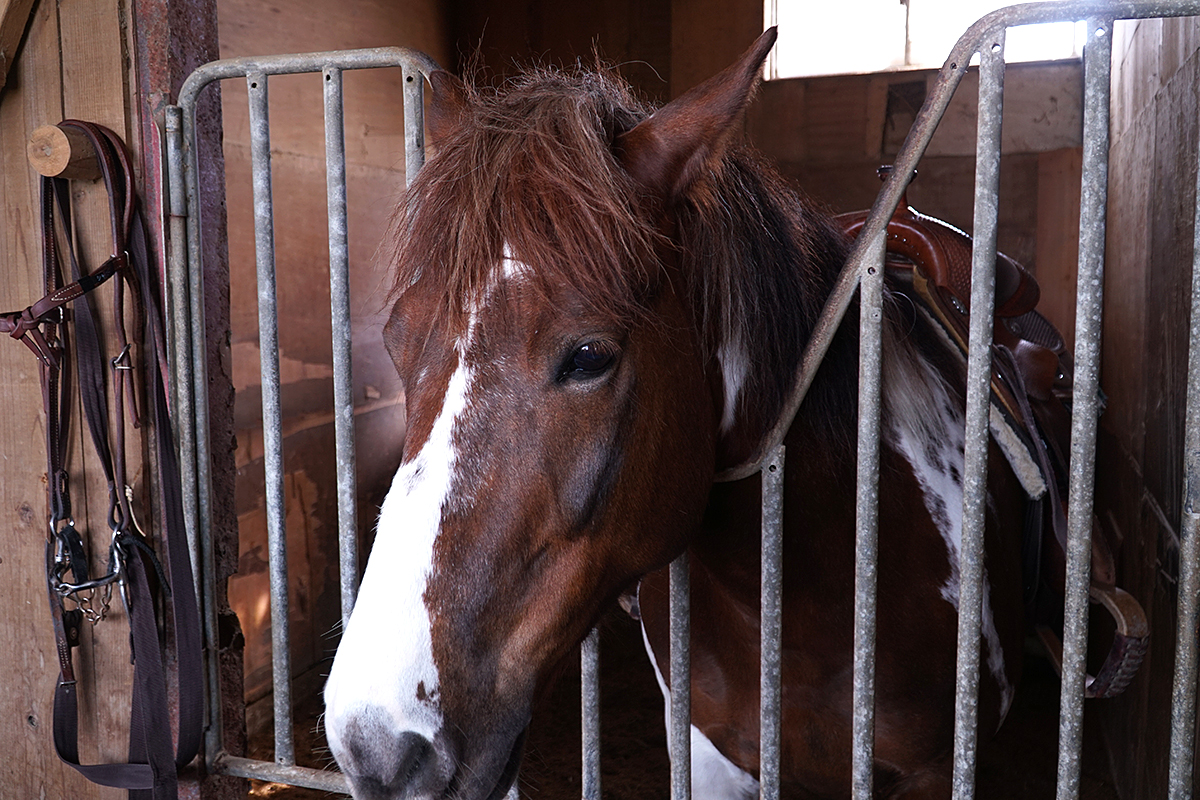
[322,67,359,628]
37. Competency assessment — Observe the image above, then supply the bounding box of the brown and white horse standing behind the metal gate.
[324,30,1024,800]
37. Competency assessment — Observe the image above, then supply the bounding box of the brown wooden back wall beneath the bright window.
[749,62,1082,347]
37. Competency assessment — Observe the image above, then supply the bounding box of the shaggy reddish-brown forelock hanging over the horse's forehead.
[385,68,660,328]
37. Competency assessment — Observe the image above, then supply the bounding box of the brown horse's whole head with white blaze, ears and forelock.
[325,31,796,800]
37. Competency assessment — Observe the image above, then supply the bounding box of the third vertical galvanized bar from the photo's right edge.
[953,28,1006,800]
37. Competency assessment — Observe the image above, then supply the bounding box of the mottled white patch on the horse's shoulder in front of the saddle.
[883,342,1014,720]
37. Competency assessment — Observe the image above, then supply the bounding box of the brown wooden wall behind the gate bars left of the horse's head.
[218,0,448,700]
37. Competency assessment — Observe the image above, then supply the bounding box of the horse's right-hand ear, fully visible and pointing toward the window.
[616,28,776,201]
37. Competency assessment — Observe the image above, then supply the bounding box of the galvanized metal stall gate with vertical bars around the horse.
[167,0,1200,800]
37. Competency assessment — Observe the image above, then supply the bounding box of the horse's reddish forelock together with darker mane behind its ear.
[391,61,853,450]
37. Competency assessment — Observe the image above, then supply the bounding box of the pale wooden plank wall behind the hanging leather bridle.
[0,0,231,799]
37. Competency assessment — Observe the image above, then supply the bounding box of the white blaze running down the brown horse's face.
[325,323,475,753]
